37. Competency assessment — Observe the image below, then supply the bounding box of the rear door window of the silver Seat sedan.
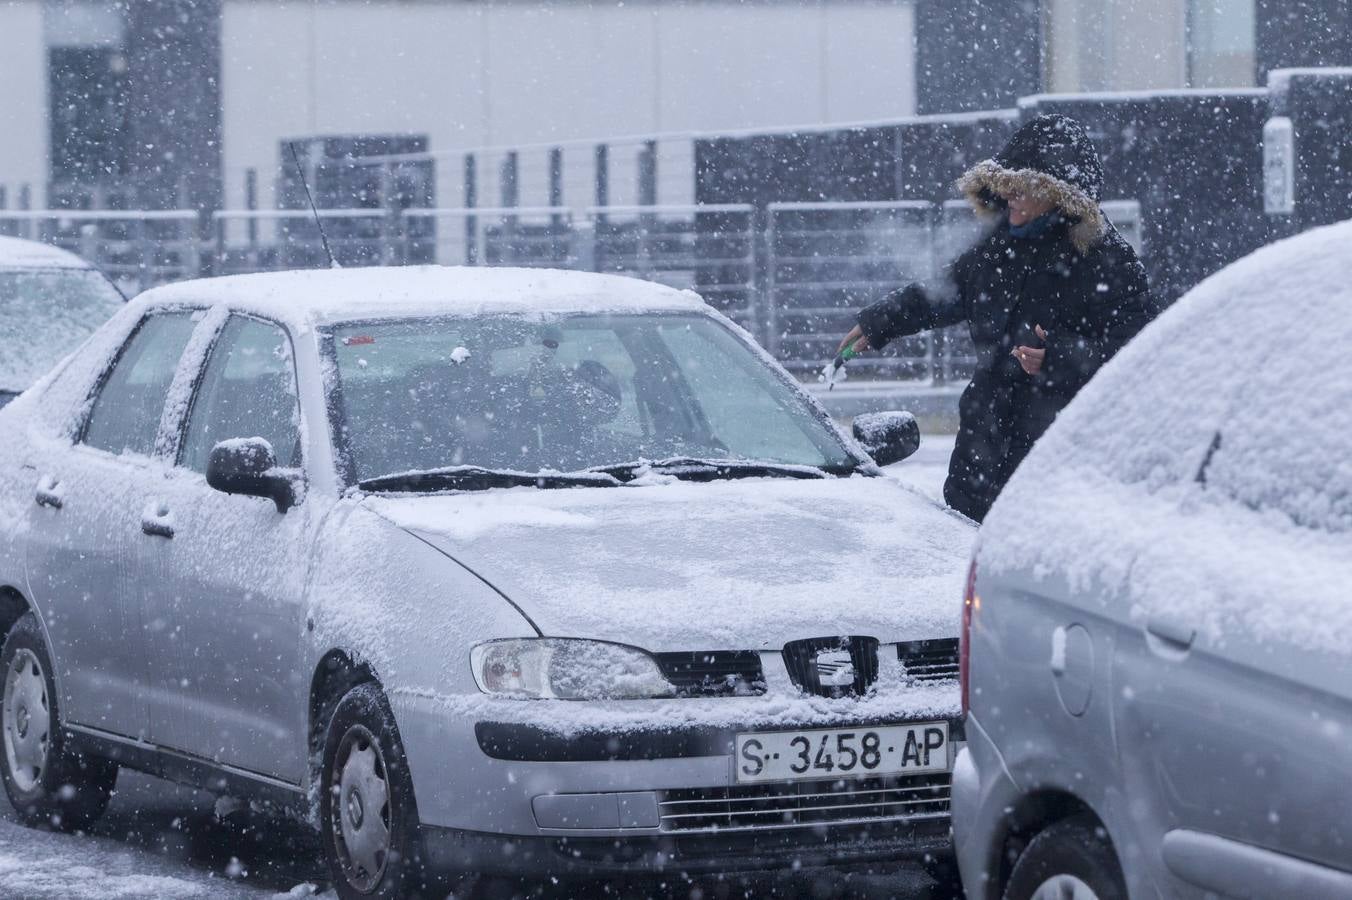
[82,311,196,455]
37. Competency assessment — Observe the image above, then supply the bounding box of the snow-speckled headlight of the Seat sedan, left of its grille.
[469,638,676,700]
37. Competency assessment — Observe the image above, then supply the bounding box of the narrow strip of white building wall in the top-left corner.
[0,0,49,208]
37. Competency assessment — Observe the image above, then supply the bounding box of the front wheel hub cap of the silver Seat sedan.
[334,726,391,892]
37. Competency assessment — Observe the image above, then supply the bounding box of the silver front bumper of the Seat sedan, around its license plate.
[392,683,963,874]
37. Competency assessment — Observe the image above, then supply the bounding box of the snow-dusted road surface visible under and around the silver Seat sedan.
[0,435,953,900]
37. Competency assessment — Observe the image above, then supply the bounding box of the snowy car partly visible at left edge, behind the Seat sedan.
[0,236,123,407]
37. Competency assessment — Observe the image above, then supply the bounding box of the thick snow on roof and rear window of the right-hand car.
[980,222,1352,656]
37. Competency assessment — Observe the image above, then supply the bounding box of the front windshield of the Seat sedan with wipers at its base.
[326,314,857,489]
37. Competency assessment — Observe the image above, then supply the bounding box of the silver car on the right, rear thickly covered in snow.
[953,222,1352,900]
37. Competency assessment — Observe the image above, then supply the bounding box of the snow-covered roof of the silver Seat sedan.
[139,266,708,326]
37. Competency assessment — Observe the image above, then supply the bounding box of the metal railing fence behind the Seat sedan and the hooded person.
[0,200,1144,384]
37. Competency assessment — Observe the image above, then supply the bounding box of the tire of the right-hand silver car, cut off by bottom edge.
[1003,816,1126,900]
